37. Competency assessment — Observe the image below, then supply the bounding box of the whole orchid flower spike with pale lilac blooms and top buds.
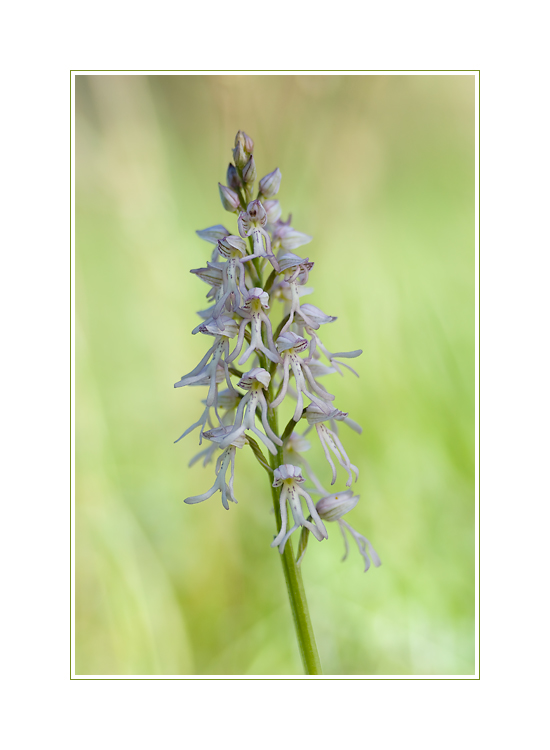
[175,131,380,570]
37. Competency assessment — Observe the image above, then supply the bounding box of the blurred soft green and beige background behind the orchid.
[76,75,475,675]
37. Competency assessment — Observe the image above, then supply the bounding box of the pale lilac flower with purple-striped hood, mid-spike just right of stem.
[270,331,334,422]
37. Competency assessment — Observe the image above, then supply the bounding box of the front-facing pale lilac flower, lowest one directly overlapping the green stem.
[271,464,328,555]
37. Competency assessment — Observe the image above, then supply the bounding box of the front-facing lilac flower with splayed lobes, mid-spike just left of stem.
[220,367,283,456]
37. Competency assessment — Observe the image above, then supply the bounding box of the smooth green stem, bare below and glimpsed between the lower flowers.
[268,402,323,674]
